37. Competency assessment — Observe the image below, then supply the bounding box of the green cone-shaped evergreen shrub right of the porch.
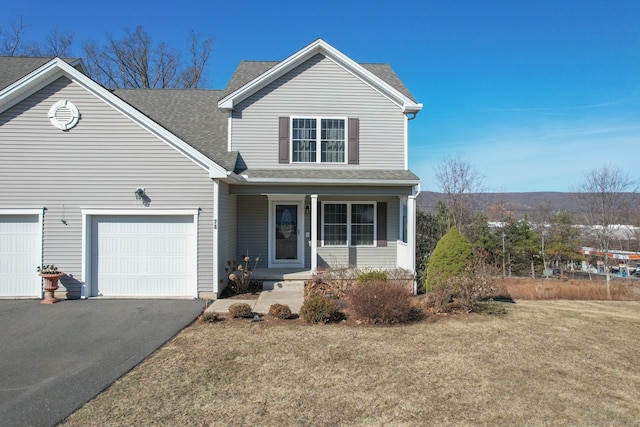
[423,227,473,292]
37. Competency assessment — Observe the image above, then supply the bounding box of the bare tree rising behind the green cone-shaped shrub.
[434,157,484,231]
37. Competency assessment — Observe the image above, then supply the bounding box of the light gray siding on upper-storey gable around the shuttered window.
[232,55,405,169]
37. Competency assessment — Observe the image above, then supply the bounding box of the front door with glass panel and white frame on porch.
[271,201,303,268]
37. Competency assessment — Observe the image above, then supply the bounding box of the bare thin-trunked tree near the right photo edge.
[576,166,637,299]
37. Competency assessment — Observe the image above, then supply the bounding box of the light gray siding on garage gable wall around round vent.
[0,77,214,296]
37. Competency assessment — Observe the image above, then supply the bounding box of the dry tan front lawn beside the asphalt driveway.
[65,301,640,426]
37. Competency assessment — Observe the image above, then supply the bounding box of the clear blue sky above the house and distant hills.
[5,0,640,192]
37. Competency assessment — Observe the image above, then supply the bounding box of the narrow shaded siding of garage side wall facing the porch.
[218,182,238,292]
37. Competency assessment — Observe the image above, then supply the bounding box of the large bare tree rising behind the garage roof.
[83,26,213,89]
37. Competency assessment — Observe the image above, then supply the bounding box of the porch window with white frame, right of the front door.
[322,202,376,246]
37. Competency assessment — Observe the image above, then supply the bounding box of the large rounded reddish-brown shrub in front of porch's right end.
[349,280,411,323]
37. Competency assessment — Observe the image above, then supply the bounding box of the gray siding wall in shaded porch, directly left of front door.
[236,196,269,268]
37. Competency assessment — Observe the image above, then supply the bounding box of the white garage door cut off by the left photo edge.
[0,215,42,298]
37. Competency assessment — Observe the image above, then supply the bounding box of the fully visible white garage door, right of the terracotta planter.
[91,215,197,297]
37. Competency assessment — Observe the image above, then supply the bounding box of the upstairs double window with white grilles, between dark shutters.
[291,118,346,163]
